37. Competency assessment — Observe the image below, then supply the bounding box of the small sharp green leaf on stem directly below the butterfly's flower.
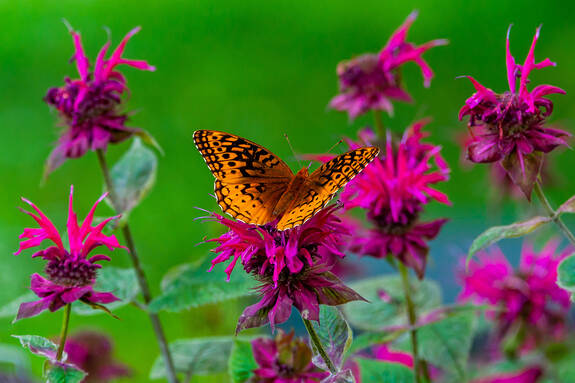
[310,305,353,370]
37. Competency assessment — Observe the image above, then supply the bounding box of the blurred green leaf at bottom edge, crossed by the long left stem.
[150,337,234,379]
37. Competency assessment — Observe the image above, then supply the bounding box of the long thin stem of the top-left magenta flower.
[96,149,178,383]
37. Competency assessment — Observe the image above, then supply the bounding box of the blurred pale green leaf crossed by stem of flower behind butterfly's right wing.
[343,275,441,332]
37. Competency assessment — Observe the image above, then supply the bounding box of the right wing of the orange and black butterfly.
[277,147,379,230]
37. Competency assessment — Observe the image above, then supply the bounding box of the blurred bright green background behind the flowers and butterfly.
[0,0,575,382]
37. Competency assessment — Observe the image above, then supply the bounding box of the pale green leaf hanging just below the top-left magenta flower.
[111,138,158,215]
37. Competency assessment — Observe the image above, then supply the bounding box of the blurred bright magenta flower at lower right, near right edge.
[459,240,573,348]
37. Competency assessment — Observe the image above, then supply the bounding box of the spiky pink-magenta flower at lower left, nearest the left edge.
[14,187,122,319]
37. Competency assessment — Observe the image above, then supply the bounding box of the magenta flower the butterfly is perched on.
[208,205,363,332]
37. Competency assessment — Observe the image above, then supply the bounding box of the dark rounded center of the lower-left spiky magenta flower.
[45,259,98,287]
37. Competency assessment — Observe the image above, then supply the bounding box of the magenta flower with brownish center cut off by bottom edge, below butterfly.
[250,330,329,383]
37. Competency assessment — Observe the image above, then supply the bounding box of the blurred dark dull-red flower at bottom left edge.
[64,331,131,383]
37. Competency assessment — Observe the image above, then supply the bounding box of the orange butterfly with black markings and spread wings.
[194,130,379,230]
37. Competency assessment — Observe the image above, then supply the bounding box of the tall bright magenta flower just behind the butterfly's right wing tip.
[341,121,450,278]
